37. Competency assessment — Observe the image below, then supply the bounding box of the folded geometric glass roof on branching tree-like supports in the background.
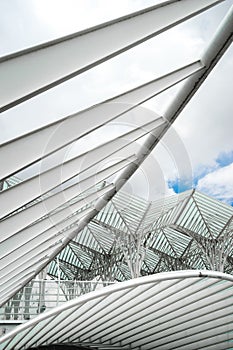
[48,190,233,281]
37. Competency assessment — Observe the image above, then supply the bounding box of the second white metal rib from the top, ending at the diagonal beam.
[0,61,203,179]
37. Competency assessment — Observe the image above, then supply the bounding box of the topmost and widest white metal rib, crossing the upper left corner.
[0,0,221,112]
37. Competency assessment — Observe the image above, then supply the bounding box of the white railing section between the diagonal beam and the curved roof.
[0,280,114,320]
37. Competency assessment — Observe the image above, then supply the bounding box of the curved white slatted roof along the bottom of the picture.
[0,270,233,350]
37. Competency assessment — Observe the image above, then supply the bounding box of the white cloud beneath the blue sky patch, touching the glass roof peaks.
[197,163,233,204]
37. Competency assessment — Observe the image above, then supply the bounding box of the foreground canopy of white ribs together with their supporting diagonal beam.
[0,0,233,305]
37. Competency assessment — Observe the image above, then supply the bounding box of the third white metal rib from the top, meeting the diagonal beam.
[0,119,164,218]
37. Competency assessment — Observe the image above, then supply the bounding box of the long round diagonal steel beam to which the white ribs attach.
[0,3,233,308]
